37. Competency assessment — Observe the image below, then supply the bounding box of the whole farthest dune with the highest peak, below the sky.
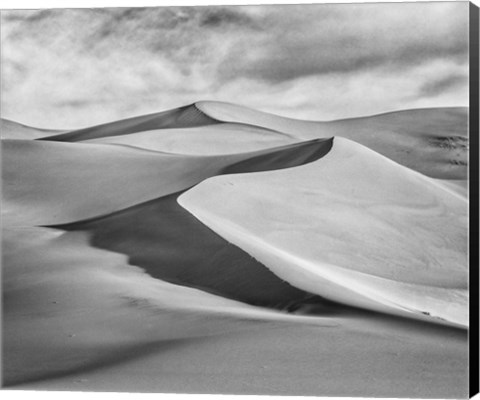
[34,101,468,179]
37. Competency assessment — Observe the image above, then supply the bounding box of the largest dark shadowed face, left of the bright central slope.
[56,193,326,308]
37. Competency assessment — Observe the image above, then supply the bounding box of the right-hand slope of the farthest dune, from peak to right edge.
[196,101,468,179]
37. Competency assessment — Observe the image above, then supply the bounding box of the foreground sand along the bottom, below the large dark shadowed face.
[3,228,468,397]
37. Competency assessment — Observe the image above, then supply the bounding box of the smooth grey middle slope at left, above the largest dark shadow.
[2,139,332,225]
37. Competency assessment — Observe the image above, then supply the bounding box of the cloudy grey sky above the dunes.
[0,2,468,129]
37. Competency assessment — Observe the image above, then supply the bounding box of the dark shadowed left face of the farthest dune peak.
[42,104,218,142]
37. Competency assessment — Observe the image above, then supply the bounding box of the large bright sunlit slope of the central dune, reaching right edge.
[179,138,468,325]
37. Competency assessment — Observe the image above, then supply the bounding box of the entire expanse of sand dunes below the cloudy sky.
[2,102,468,398]
